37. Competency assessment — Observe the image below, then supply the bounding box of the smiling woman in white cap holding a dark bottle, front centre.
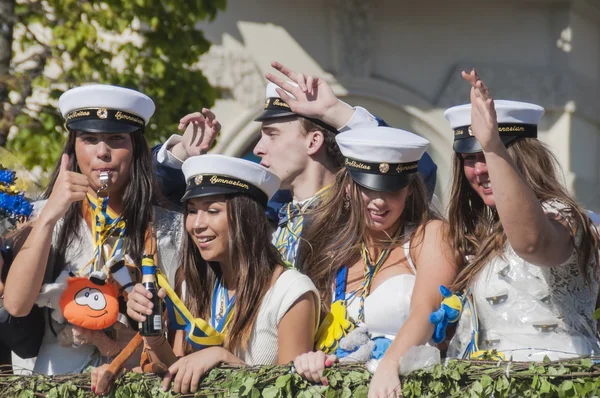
[122,155,319,393]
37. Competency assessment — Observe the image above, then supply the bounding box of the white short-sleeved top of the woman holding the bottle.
[234,269,320,366]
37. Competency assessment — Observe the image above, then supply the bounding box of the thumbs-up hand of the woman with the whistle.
[40,154,90,223]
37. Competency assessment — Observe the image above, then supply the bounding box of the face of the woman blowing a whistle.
[75,131,133,193]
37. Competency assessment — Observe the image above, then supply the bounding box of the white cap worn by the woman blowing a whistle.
[58,84,155,133]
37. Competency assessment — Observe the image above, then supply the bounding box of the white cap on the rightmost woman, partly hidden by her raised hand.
[444,100,544,153]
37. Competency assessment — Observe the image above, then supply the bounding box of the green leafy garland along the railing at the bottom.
[0,358,600,398]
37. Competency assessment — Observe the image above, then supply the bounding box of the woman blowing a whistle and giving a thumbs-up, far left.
[4,85,188,374]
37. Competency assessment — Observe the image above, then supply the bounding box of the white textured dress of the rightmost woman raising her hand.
[448,201,600,361]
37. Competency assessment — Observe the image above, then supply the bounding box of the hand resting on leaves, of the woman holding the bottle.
[163,347,225,394]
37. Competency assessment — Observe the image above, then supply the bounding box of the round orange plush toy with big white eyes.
[60,278,119,330]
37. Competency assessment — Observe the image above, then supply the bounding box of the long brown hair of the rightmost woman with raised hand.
[449,138,598,290]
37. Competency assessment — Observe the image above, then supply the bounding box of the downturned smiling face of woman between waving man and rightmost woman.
[360,187,410,236]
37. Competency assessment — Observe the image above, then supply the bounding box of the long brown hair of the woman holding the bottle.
[175,195,283,353]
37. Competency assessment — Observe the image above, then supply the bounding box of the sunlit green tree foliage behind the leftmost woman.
[0,0,226,170]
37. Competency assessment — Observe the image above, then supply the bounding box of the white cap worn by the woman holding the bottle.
[181,155,281,206]
